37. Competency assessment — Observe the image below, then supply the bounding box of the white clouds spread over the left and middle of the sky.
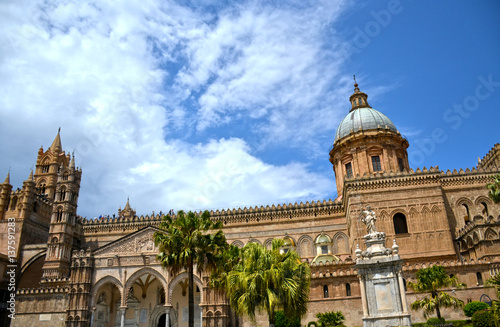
[0,0,345,217]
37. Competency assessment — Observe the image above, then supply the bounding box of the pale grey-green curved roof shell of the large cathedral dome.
[335,108,398,142]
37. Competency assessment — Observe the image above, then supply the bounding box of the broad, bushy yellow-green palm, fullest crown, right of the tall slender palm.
[224,240,311,327]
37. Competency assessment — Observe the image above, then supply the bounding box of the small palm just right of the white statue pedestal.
[408,266,465,319]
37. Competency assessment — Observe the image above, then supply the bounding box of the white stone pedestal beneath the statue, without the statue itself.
[355,232,411,327]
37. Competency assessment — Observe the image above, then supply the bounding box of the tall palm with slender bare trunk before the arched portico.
[153,211,228,327]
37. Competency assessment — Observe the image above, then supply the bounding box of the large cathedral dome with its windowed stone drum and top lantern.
[330,80,410,197]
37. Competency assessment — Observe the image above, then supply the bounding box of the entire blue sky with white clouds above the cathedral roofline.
[0,0,500,217]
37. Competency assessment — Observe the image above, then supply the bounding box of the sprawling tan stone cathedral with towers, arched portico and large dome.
[0,84,500,327]
